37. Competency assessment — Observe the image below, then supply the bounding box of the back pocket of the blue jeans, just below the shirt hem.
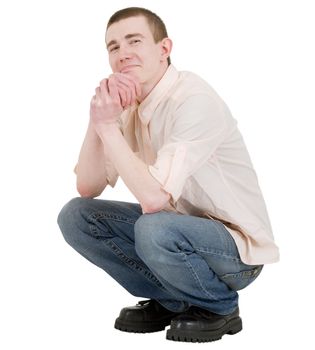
[220,265,263,290]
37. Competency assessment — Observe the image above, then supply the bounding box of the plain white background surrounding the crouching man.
[0,0,315,350]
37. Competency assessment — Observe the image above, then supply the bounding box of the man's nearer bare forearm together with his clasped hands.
[90,75,170,213]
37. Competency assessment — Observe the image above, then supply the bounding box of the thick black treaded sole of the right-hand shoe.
[166,317,242,343]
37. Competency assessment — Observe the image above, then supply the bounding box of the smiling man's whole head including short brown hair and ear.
[106,7,172,92]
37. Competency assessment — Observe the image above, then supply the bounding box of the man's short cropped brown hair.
[106,7,171,65]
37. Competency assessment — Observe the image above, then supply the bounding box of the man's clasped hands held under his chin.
[90,73,141,128]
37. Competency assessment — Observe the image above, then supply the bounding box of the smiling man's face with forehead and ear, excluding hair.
[106,16,171,85]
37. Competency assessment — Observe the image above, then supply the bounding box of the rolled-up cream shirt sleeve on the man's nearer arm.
[149,94,227,202]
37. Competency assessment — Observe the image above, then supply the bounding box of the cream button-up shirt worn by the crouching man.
[106,65,279,265]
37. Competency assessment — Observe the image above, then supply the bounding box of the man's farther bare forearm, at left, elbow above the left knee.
[75,122,107,197]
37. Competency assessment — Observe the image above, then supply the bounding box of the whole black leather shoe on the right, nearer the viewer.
[166,306,242,342]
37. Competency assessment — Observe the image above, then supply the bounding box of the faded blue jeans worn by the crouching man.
[58,198,262,315]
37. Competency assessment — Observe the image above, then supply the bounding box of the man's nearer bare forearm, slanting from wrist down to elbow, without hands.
[97,124,170,212]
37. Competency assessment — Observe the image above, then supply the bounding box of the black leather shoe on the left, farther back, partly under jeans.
[115,300,178,333]
